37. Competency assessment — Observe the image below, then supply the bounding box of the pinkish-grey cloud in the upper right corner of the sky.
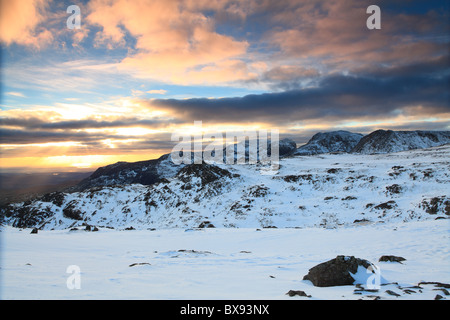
[265,0,449,71]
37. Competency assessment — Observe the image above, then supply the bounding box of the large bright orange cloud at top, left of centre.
[87,0,252,84]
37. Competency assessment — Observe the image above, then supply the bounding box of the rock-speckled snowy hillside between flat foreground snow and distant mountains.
[1,146,450,230]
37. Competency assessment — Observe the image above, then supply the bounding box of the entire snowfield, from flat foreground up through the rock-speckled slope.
[0,145,450,299]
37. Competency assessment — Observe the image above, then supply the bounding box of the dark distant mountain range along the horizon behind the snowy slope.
[68,130,450,192]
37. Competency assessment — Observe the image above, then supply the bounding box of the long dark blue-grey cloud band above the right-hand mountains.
[151,57,450,124]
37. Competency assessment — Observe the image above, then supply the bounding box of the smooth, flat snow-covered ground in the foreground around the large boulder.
[0,219,450,300]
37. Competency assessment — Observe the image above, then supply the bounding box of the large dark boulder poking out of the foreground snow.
[303,256,372,287]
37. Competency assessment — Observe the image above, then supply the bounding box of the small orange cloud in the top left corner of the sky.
[0,0,53,49]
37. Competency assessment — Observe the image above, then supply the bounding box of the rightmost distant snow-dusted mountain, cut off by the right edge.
[351,130,450,154]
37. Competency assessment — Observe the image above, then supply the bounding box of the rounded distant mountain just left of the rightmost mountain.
[295,130,363,156]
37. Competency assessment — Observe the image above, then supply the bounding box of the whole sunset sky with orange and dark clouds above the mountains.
[0,0,450,171]
